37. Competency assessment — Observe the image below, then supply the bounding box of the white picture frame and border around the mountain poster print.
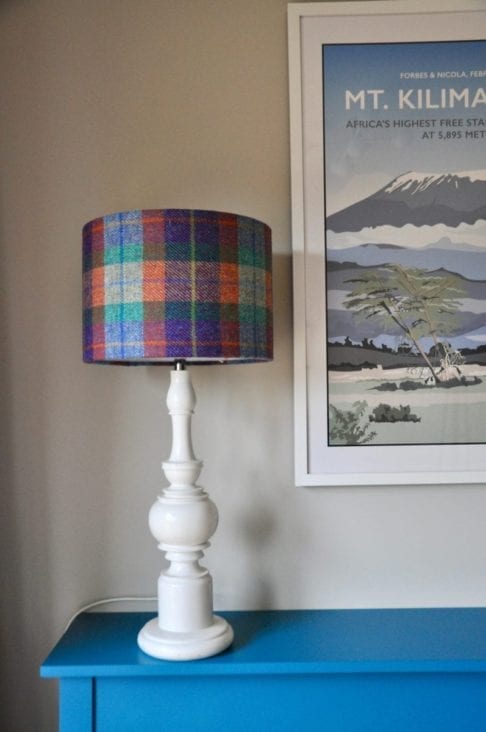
[288,5,486,486]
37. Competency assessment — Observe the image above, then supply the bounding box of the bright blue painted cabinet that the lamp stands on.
[41,608,486,732]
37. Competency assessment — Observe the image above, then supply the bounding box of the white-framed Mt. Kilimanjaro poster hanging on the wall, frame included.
[288,5,486,485]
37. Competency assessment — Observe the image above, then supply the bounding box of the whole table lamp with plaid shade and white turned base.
[83,209,273,660]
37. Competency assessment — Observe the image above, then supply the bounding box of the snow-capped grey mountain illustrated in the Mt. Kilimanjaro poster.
[326,170,486,233]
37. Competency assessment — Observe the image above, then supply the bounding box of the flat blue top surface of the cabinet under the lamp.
[41,608,486,677]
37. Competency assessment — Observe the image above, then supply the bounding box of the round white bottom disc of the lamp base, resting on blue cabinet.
[137,615,233,661]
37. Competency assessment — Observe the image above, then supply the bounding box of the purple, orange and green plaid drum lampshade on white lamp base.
[83,209,273,363]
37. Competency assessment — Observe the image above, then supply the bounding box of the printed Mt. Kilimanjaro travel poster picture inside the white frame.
[322,41,486,448]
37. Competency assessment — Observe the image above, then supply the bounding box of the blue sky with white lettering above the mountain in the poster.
[323,41,486,213]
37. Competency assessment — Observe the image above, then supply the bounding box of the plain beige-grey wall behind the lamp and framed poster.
[0,0,486,732]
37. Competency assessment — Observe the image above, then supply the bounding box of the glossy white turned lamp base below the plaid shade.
[138,365,233,661]
